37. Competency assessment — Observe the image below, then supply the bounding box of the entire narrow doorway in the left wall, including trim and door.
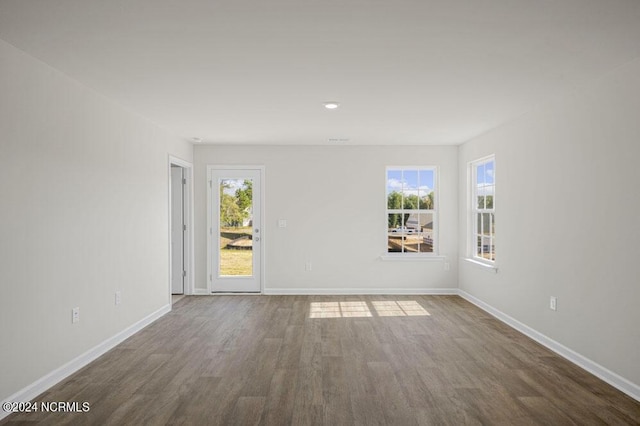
[169,156,193,303]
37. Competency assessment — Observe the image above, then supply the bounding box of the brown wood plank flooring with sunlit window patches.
[0,296,640,426]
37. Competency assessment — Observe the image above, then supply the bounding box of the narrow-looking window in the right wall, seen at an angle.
[469,156,496,263]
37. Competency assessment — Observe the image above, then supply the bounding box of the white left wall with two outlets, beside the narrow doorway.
[0,41,192,399]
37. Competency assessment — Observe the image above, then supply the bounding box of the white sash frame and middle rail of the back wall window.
[382,165,440,260]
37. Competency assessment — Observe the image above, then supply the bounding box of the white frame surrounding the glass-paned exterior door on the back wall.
[207,164,266,295]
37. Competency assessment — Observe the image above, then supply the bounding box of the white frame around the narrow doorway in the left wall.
[167,155,195,298]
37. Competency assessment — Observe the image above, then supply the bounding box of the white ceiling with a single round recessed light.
[0,0,640,145]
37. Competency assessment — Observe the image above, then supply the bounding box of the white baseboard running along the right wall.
[458,289,640,401]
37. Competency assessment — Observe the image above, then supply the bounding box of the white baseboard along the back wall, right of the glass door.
[264,288,458,296]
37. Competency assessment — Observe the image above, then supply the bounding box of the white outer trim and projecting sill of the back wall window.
[379,166,438,262]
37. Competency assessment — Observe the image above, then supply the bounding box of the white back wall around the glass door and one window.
[194,146,458,292]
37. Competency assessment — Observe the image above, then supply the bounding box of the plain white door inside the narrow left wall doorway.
[171,166,185,294]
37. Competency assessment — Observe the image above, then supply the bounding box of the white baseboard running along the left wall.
[0,304,171,420]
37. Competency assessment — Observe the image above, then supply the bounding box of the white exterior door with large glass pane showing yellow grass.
[209,167,262,293]
